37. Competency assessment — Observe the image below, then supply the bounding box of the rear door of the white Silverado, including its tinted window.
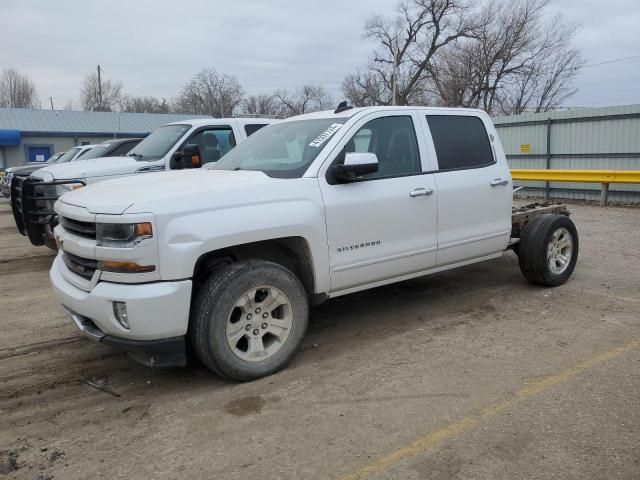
[423,112,513,266]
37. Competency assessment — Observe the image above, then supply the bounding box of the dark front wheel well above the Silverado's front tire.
[193,237,315,296]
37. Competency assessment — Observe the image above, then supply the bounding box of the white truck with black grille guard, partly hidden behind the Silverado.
[11,118,273,249]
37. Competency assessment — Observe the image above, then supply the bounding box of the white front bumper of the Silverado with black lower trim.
[49,254,191,366]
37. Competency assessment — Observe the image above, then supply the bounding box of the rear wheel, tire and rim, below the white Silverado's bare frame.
[518,215,578,287]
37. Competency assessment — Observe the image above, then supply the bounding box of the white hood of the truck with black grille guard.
[32,157,150,181]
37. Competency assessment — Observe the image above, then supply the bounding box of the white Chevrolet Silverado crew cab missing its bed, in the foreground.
[50,104,578,381]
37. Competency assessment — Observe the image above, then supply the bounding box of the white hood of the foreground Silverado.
[60,169,286,215]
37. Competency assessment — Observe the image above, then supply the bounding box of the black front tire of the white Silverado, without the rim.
[190,260,309,381]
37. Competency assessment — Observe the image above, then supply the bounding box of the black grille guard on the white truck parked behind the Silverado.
[11,176,86,248]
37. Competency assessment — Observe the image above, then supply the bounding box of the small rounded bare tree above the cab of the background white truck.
[175,68,243,117]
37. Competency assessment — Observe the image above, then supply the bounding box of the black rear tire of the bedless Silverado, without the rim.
[518,215,579,287]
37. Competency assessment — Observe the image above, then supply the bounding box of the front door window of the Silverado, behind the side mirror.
[345,116,422,179]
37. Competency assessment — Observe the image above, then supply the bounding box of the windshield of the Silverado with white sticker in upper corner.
[208,118,345,178]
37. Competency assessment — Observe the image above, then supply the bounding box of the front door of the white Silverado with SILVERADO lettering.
[319,110,437,293]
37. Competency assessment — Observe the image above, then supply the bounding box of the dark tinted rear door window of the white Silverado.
[427,115,494,170]
